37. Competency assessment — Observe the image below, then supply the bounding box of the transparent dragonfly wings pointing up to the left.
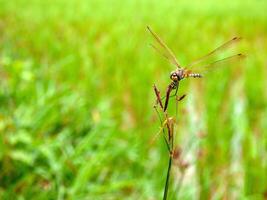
[147,26,180,68]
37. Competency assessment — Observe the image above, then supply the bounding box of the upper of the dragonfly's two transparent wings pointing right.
[187,37,242,67]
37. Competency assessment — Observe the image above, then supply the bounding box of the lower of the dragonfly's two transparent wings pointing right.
[186,53,246,73]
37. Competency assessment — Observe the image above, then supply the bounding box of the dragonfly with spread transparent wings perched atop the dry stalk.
[147,26,245,111]
